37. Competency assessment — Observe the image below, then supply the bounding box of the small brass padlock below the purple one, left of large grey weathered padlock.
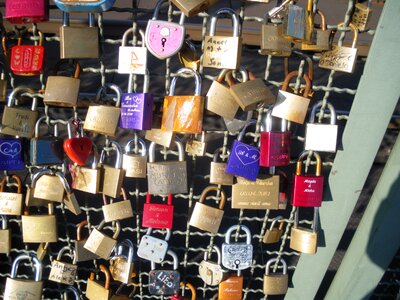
[122,138,147,178]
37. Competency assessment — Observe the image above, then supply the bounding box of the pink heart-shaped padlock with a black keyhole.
[145,0,185,59]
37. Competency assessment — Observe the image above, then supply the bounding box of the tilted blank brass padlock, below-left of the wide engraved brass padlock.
[189,186,226,234]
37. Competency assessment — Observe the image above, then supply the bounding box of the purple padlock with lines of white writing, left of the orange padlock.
[119,69,153,130]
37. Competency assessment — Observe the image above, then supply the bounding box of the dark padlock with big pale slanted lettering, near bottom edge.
[149,250,181,296]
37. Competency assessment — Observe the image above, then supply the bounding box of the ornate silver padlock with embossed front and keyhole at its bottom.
[222,225,253,270]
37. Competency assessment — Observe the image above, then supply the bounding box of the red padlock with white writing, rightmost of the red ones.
[292,150,324,207]
